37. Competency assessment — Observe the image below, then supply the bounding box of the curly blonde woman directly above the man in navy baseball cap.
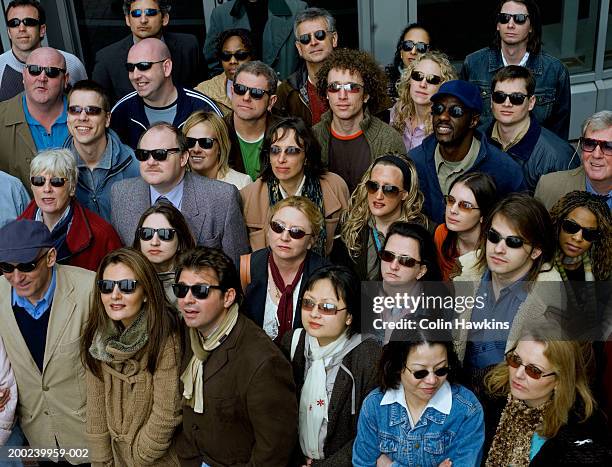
[390,51,457,151]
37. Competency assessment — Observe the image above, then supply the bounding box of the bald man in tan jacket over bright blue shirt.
[0,47,69,192]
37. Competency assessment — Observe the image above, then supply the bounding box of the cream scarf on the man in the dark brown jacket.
[181,303,238,413]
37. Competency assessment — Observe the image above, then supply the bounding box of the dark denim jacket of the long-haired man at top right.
[461,47,571,140]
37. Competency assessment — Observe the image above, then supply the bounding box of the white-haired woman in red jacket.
[19,149,121,271]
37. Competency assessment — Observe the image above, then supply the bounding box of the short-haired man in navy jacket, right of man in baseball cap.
[486,65,580,193]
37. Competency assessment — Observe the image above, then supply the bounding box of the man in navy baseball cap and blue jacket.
[410,80,525,224]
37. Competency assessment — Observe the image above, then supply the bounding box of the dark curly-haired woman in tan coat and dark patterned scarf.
[240,118,349,256]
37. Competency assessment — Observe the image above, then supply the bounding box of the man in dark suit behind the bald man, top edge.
[92,0,206,103]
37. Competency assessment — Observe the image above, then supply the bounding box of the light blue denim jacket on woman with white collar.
[353,384,484,467]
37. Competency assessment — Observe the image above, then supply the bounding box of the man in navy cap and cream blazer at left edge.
[0,220,95,464]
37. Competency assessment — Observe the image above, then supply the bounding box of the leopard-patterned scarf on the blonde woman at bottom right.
[485,394,550,467]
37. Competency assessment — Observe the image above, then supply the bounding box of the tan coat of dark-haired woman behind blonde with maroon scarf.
[240,172,349,255]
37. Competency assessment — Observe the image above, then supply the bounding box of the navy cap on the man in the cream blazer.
[0,219,54,263]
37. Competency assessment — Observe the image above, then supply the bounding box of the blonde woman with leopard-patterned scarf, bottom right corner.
[485,336,612,467]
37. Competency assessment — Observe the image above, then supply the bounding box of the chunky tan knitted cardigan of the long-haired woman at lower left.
[87,336,181,467]
